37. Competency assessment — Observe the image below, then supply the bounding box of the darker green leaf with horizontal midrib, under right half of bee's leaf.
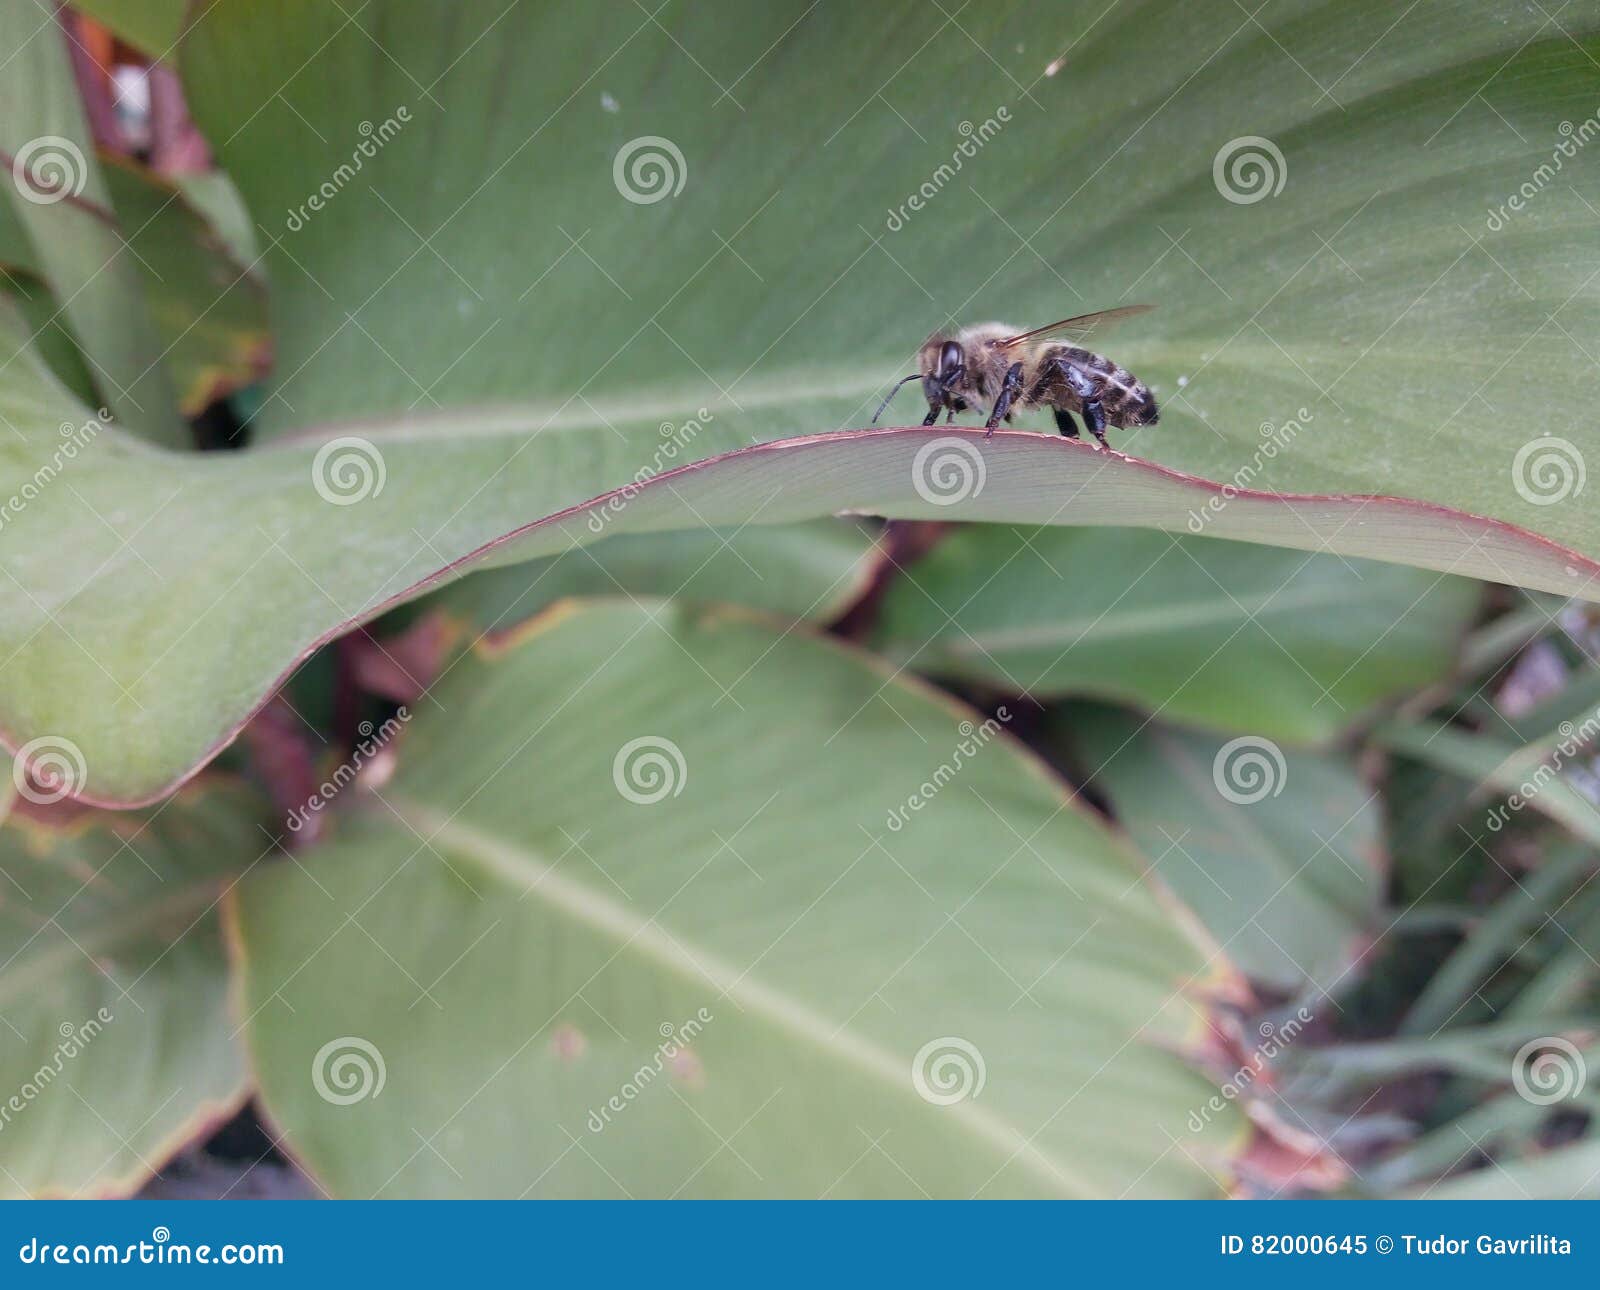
[875,527,1478,739]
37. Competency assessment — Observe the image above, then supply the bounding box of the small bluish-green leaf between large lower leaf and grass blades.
[1058,707,1386,994]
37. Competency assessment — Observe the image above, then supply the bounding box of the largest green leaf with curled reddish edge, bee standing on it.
[15,0,1600,802]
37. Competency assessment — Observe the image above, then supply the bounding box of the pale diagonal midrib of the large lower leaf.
[386,794,1101,1197]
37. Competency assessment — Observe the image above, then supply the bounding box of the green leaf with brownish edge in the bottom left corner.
[0,777,256,1197]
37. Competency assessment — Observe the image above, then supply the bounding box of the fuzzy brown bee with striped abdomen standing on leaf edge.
[872,304,1160,448]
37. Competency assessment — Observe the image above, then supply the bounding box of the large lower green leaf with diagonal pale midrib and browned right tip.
[235,603,1242,1196]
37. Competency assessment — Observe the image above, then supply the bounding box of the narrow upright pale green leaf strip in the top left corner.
[0,0,189,447]
